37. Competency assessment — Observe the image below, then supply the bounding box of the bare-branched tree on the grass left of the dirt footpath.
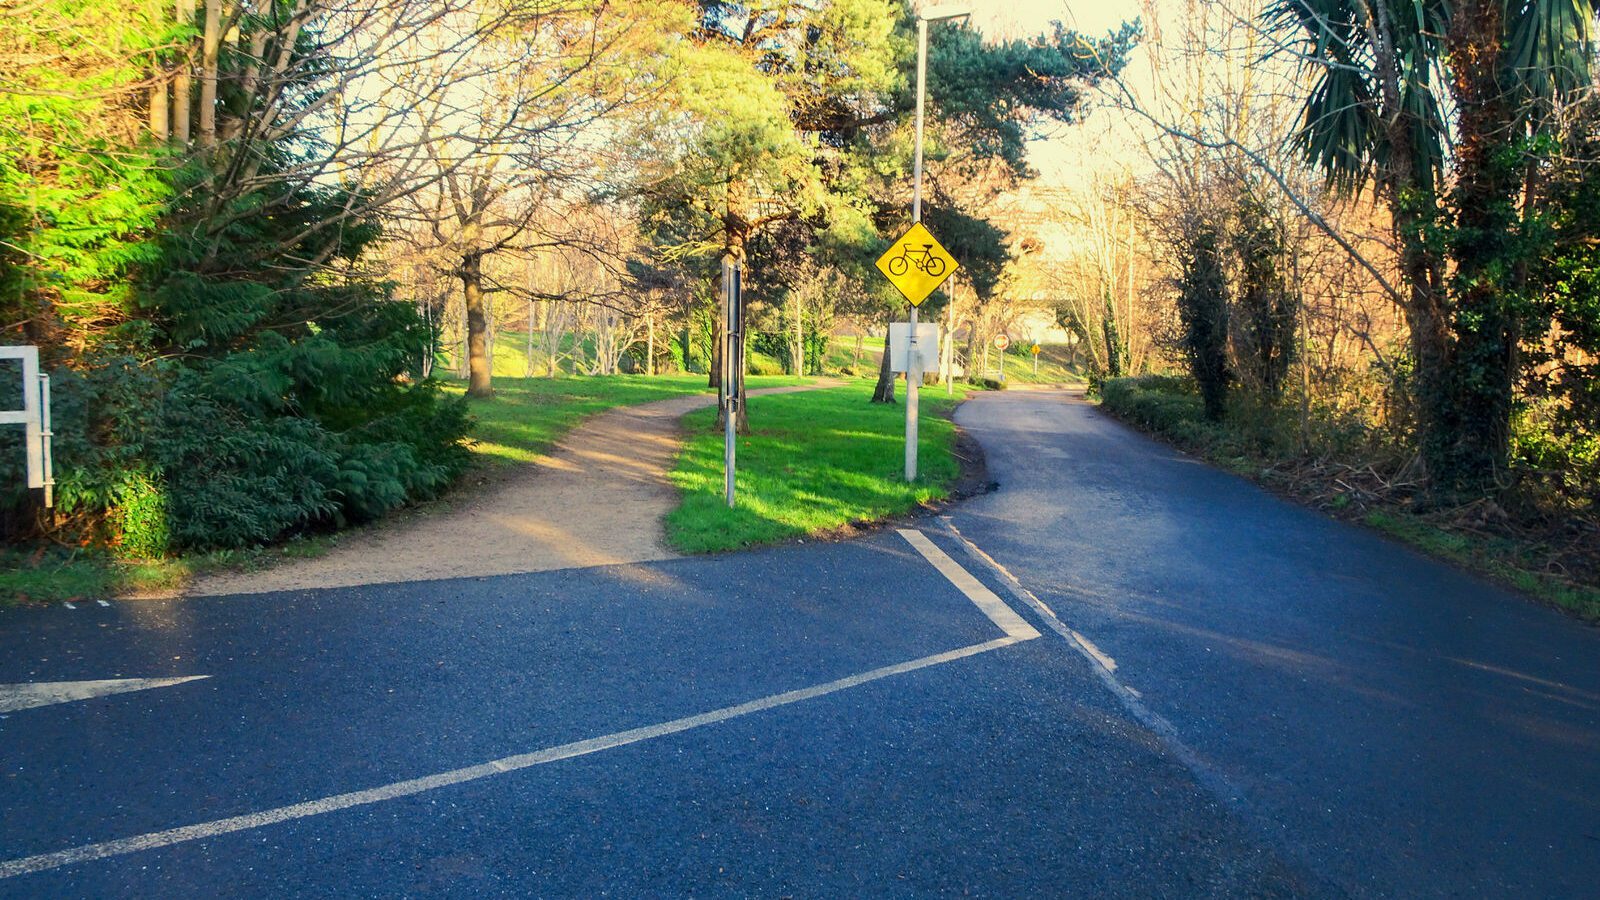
[397,0,685,397]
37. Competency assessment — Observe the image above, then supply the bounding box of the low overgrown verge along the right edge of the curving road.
[1101,376,1600,621]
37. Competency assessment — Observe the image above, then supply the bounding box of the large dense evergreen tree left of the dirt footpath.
[0,0,486,556]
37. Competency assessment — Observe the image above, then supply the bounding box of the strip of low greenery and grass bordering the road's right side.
[1101,376,1600,621]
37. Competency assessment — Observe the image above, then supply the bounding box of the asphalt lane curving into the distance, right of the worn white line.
[952,392,1600,897]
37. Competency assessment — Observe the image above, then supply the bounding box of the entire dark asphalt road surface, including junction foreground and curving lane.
[0,394,1600,897]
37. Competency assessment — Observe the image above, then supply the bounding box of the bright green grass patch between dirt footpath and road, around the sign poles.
[667,380,965,552]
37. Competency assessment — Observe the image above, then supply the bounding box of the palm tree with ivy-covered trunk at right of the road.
[1264,0,1594,493]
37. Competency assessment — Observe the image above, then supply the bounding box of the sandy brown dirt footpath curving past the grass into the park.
[184,383,835,596]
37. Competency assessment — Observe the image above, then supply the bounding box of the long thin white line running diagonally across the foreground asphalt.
[0,630,1038,878]
